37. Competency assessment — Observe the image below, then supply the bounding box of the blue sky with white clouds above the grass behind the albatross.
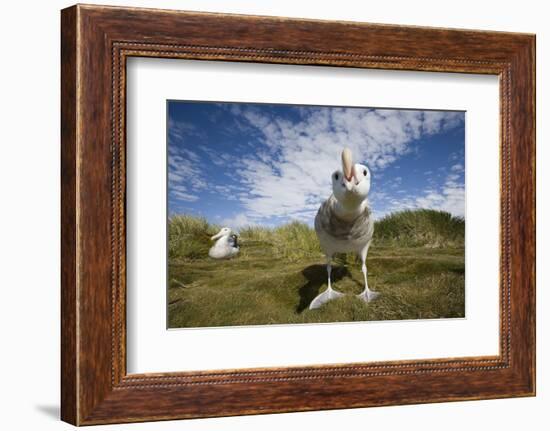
[167,101,465,229]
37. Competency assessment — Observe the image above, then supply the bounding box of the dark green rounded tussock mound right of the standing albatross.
[374,209,464,248]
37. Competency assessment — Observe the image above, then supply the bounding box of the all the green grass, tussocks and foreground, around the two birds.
[168,210,464,328]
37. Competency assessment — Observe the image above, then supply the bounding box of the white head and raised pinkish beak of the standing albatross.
[332,148,370,209]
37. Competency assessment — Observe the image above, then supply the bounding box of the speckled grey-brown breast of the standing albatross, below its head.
[315,196,374,241]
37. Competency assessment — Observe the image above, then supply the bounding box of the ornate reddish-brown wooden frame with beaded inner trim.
[61,5,535,425]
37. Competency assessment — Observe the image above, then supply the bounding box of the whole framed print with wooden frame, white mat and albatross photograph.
[61,5,535,425]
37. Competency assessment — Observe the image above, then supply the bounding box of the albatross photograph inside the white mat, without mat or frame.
[166,100,465,328]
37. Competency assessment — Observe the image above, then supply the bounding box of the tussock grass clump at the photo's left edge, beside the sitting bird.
[168,215,219,259]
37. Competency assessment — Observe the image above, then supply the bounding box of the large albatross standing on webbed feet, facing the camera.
[309,148,379,310]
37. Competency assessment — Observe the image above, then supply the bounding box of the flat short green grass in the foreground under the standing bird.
[168,244,464,328]
